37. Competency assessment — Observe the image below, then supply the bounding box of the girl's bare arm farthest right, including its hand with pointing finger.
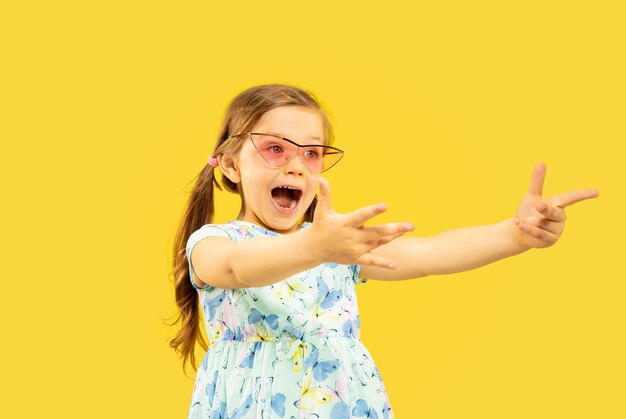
[360,163,599,280]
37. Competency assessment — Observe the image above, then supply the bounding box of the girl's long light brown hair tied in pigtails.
[169,84,334,370]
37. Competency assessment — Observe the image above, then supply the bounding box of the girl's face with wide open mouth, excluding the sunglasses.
[224,106,324,234]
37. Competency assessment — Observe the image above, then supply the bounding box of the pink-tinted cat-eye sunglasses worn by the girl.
[251,134,343,173]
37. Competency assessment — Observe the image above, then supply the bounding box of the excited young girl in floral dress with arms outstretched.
[170,84,598,419]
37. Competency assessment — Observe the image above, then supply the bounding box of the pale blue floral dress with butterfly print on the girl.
[186,220,394,419]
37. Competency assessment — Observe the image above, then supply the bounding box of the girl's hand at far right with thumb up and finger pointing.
[514,163,599,249]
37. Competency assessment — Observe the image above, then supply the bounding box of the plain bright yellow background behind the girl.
[0,1,626,419]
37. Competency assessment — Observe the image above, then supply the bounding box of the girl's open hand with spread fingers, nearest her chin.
[308,177,414,269]
